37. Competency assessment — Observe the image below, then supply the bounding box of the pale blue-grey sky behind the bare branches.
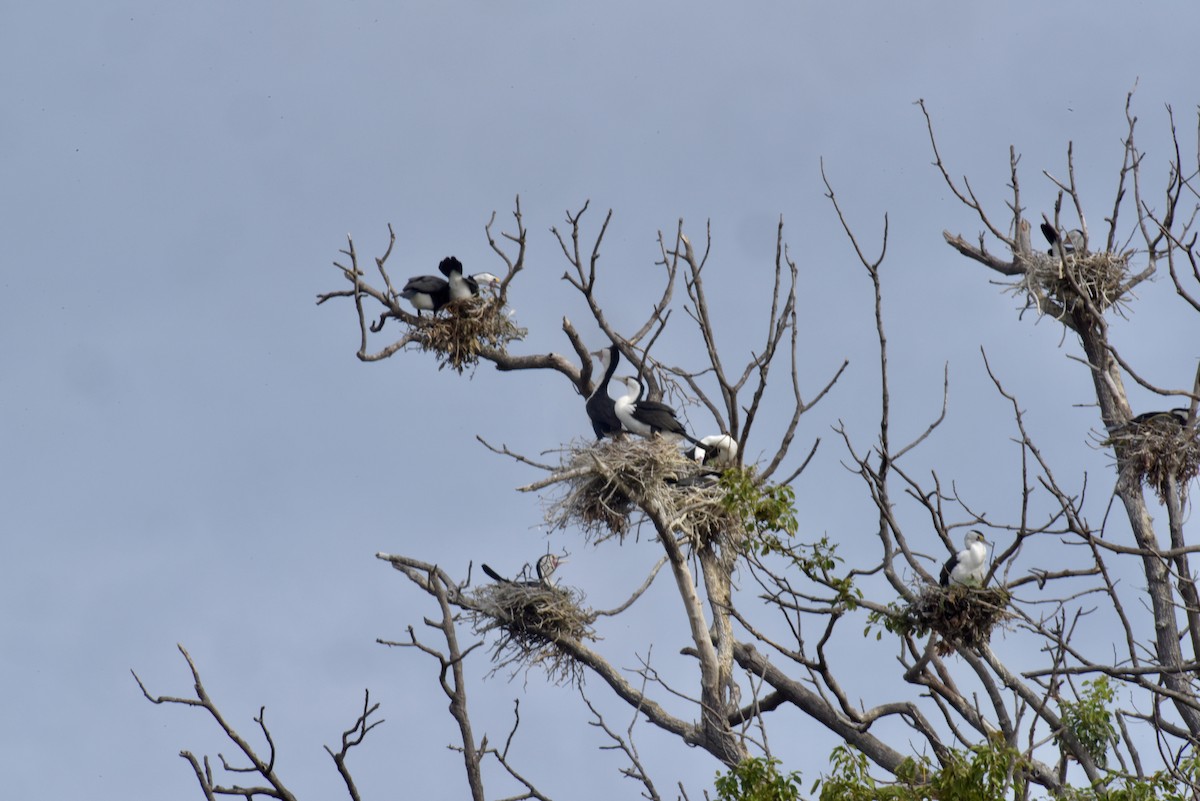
[0,1,1200,801]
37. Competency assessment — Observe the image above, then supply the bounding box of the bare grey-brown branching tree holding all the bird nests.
[143,102,1200,799]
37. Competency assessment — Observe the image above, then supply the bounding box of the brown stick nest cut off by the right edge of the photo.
[1104,415,1200,496]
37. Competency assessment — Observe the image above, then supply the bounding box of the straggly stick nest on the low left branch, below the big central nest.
[472,582,596,683]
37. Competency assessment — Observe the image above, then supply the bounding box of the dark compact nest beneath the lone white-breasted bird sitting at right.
[898,584,1012,656]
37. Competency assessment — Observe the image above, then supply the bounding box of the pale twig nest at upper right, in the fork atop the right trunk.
[1013,252,1129,312]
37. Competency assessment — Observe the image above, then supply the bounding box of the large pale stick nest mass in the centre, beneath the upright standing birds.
[546,436,745,547]
